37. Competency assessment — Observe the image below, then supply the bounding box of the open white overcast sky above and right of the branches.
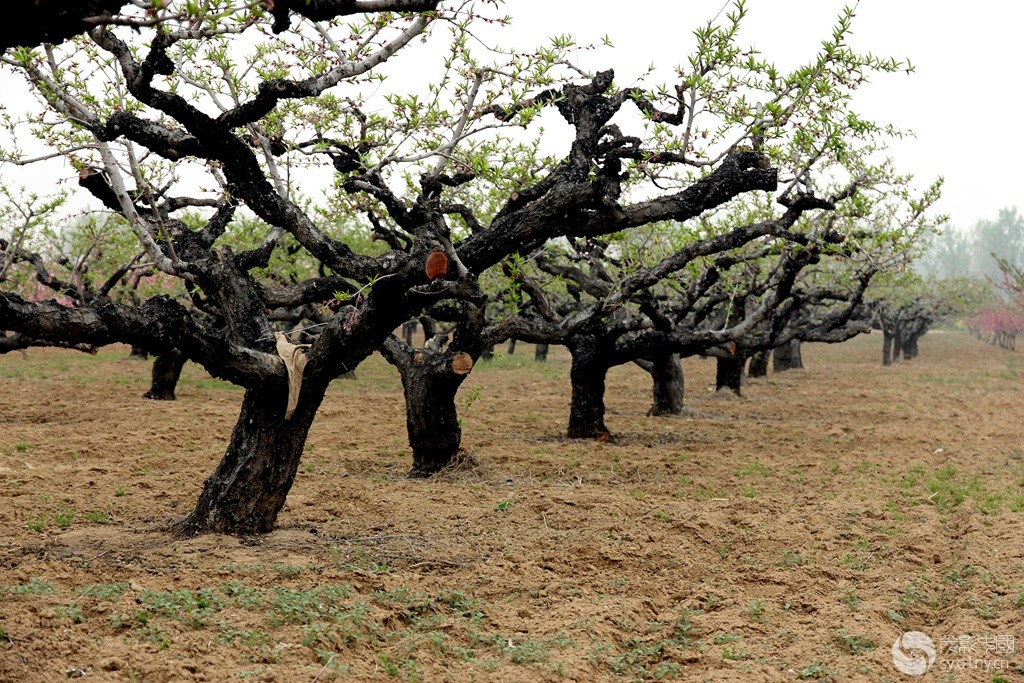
[493,0,1024,227]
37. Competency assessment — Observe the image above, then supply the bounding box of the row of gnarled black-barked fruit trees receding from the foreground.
[0,0,941,533]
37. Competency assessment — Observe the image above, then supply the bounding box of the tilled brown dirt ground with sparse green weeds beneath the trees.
[0,332,1024,683]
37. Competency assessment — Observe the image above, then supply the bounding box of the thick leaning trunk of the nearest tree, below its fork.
[177,383,326,536]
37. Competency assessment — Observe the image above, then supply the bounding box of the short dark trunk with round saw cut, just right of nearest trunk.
[382,337,473,477]
